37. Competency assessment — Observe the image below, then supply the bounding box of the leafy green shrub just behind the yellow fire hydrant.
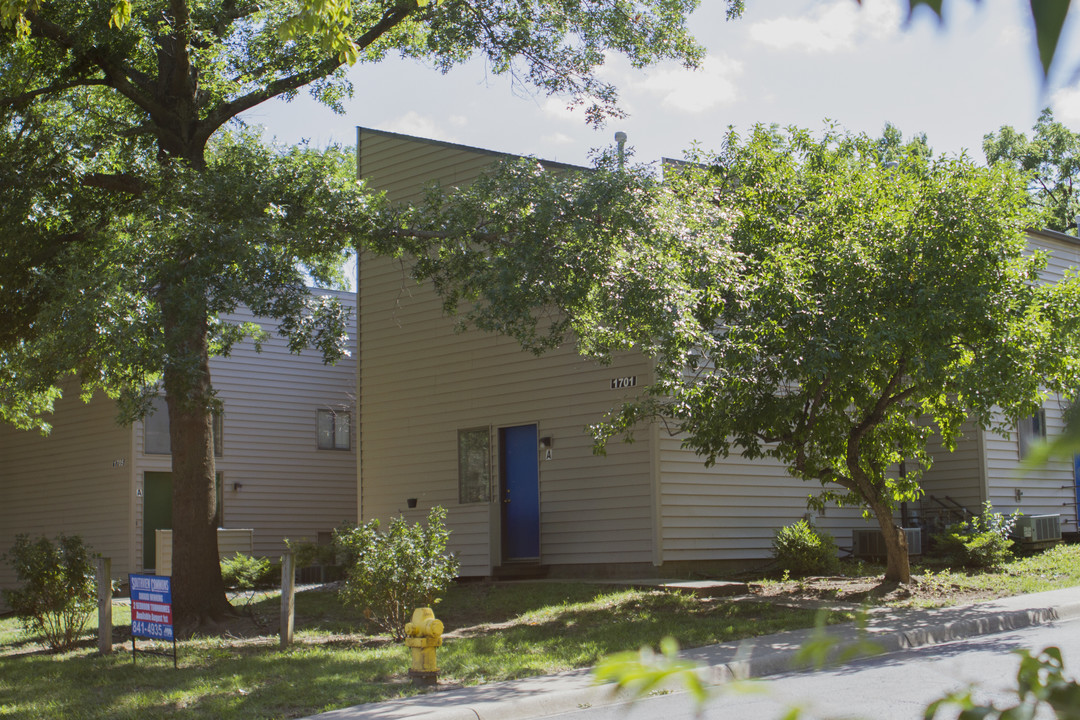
[334,507,458,640]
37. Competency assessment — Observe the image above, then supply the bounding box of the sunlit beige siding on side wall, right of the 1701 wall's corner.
[660,434,866,562]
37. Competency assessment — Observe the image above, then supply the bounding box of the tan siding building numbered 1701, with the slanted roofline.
[357,128,864,575]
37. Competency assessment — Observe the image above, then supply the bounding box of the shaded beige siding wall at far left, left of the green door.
[0,384,136,587]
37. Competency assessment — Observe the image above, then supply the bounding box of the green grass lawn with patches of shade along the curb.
[0,546,1080,720]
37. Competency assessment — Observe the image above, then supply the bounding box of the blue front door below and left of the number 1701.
[499,425,540,560]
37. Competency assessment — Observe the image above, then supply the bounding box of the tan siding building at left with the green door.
[0,290,357,600]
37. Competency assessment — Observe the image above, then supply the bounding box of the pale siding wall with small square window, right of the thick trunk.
[133,290,357,560]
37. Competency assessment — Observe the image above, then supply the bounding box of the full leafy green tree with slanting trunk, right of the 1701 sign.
[378,126,1078,581]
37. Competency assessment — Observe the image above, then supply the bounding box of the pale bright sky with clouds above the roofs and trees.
[244,0,1080,170]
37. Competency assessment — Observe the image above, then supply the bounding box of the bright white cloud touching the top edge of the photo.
[748,0,902,53]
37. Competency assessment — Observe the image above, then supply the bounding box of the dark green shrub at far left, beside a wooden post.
[3,534,97,651]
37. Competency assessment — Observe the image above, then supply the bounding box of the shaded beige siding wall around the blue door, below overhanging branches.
[361,250,652,575]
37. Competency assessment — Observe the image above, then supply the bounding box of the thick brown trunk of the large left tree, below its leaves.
[164,312,232,635]
